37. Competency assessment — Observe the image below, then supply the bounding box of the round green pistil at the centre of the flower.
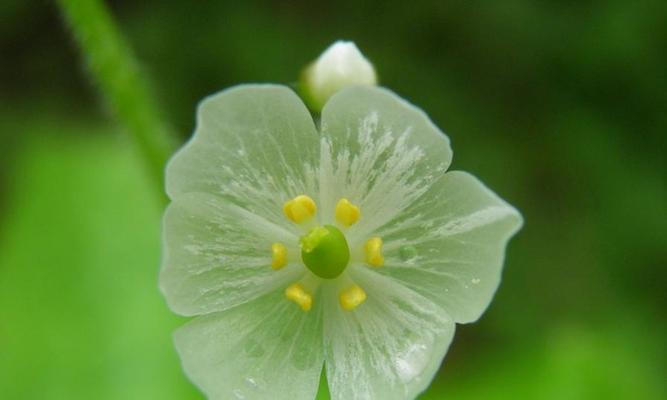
[300,225,350,279]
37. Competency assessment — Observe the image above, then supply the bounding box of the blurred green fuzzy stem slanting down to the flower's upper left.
[58,0,175,200]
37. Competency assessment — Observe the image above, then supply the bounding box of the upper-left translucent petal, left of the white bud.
[167,85,319,229]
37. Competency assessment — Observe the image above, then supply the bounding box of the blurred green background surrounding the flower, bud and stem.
[0,0,667,400]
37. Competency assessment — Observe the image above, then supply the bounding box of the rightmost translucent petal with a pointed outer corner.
[377,171,522,323]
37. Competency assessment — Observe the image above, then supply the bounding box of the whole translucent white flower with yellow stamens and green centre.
[160,85,521,400]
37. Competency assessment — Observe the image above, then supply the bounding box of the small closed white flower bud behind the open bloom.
[301,40,377,111]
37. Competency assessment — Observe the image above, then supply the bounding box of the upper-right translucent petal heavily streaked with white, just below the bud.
[319,86,452,244]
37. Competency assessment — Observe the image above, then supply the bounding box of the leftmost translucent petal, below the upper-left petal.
[160,193,305,315]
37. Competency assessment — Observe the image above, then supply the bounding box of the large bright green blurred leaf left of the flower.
[0,121,201,400]
